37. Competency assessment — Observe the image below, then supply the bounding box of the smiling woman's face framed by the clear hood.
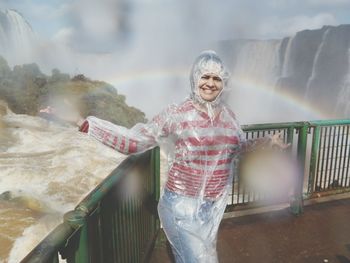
[198,73,223,101]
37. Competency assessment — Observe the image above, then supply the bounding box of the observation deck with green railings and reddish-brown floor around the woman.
[22,120,350,263]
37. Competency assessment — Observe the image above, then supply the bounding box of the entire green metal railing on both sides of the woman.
[22,120,350,263]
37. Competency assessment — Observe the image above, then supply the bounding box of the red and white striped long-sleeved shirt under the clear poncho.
[80,99,260,199]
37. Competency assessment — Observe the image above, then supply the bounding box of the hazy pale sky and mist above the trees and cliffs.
[0,0,350,116]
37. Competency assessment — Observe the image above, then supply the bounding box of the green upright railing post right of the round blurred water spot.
[290,122,309,215]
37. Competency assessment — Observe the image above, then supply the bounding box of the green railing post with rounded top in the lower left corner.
[64,210,89,263]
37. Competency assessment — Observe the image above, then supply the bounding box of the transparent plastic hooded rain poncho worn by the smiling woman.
[81,51,270,263]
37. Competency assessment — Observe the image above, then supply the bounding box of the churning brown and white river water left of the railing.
[0,105,126,262]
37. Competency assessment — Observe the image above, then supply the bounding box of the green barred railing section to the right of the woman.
[227,120,350,214]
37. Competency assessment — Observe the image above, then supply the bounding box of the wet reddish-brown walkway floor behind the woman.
[150,198,350,263]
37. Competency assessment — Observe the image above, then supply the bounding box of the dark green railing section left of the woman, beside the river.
[21,148,160,263]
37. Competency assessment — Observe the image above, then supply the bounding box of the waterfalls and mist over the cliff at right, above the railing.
[220,25,350,120]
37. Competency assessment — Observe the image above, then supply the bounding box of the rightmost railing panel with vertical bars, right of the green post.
[305,120,350,197]
